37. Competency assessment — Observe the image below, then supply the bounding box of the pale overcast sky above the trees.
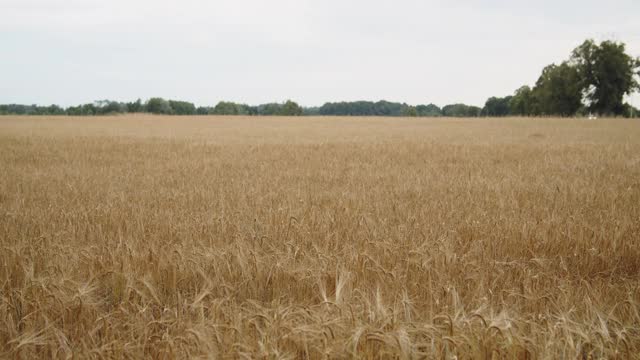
[0,0,640,106]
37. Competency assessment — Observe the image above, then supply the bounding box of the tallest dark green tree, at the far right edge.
[571,40,640,115]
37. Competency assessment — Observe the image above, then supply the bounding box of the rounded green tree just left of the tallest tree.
[532,62,582,116]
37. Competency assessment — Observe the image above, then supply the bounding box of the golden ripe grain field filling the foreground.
[0,115,640,359]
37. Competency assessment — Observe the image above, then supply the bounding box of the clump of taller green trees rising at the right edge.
[482,40,640,117]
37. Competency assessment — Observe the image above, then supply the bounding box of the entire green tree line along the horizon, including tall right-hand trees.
[0,40,640,117]
